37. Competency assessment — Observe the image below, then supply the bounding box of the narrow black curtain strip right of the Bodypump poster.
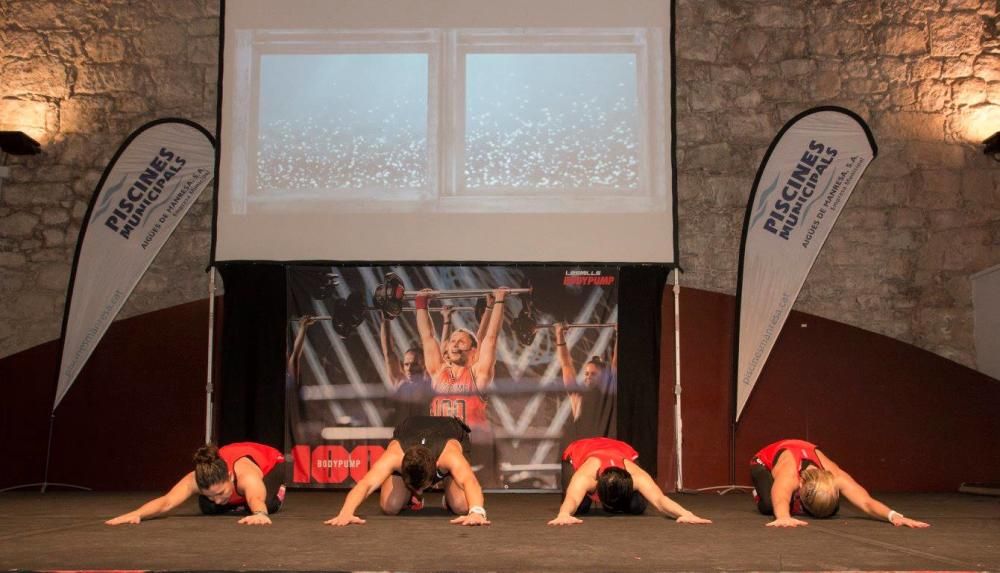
[618,266,669,477]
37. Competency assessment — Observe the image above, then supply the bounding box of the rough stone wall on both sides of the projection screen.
[0,0,1000,366]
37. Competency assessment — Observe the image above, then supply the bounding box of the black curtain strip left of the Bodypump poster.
[216,263,287,450]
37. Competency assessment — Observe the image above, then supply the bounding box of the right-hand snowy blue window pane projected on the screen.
[464,54,640,194]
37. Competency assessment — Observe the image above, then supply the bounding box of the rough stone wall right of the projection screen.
[677,0,1000,366]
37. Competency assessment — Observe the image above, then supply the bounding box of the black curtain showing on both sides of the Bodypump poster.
[217,263,669,475]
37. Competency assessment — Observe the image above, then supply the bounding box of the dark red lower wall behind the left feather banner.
[0,299,208,490]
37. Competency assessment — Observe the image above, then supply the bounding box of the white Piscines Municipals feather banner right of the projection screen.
[734,107,878,421]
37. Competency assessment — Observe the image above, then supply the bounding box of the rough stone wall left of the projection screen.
[0,0,219,356]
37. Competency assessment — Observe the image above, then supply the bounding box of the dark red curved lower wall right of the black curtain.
[658,289,1000,491]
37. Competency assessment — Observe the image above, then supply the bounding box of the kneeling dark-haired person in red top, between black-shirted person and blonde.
[549,437,712,525]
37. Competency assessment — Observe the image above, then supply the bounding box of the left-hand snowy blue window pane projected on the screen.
[255,54,428,200]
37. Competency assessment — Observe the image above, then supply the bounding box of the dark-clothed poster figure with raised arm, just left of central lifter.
[379,316,433,422]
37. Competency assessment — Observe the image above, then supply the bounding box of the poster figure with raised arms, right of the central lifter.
[553,322,618,438]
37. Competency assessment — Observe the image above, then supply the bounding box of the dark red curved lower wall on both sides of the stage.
[0,289,1000,491]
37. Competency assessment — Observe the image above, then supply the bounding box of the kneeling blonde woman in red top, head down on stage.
[750,439,929,527]
